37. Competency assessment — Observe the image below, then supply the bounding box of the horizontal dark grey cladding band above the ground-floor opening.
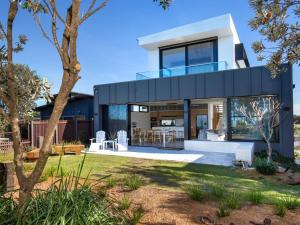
[95,67,284,105]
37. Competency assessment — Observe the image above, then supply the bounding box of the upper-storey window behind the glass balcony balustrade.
[160,40,217,77]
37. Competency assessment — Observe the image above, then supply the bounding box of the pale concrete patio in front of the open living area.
[87,146,235,166]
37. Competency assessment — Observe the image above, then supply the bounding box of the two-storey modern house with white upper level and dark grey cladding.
[94,14,294,160]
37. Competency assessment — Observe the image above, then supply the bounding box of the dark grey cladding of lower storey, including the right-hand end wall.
[94,66,294,157]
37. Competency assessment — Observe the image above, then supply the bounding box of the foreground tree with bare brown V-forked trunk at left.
[0,0,171,210]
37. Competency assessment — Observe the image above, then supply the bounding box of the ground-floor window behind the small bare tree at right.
[231,96,279,141]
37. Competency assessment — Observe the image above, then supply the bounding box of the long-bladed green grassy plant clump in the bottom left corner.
[0,157,131,225]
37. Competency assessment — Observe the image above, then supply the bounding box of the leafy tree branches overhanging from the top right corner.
[249,0,300,77]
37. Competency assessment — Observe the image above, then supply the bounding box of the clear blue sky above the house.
[0,0,300,115]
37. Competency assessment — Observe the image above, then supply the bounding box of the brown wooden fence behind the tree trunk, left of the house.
[29,119,93,147]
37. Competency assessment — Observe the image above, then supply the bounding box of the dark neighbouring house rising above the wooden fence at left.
[36,92,93,120]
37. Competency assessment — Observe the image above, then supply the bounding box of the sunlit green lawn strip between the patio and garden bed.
[4,154,300,203]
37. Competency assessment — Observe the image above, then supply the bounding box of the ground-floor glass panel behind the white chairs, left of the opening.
[103,105,128,134]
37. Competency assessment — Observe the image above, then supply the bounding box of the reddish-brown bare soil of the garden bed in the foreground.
[110,186,300,225]
